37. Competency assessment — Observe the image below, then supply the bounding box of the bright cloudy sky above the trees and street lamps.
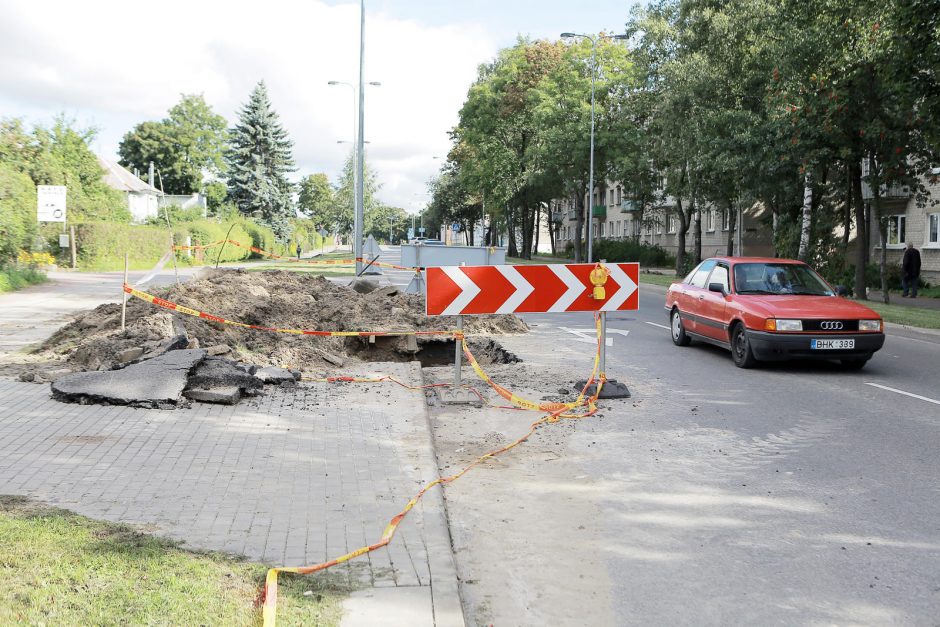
[0,0,633,212]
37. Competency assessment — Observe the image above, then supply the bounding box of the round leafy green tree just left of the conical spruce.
[118,94,227,194]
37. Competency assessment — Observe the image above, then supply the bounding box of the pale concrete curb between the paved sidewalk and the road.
[411,361,466,627]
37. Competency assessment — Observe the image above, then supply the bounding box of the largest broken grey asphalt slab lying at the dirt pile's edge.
[52,349,206,409]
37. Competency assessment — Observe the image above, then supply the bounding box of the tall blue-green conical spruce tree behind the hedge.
[225,81,296,242]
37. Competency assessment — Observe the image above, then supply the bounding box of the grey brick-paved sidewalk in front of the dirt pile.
[0,363,463,625]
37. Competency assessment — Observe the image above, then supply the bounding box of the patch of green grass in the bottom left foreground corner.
[0,496,350,625]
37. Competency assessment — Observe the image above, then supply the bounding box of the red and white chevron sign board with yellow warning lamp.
[426,263,640,316]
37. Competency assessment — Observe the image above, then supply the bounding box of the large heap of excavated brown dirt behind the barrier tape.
[40,270,528,371]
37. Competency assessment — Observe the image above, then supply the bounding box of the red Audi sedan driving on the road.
[666,257,885,369]
